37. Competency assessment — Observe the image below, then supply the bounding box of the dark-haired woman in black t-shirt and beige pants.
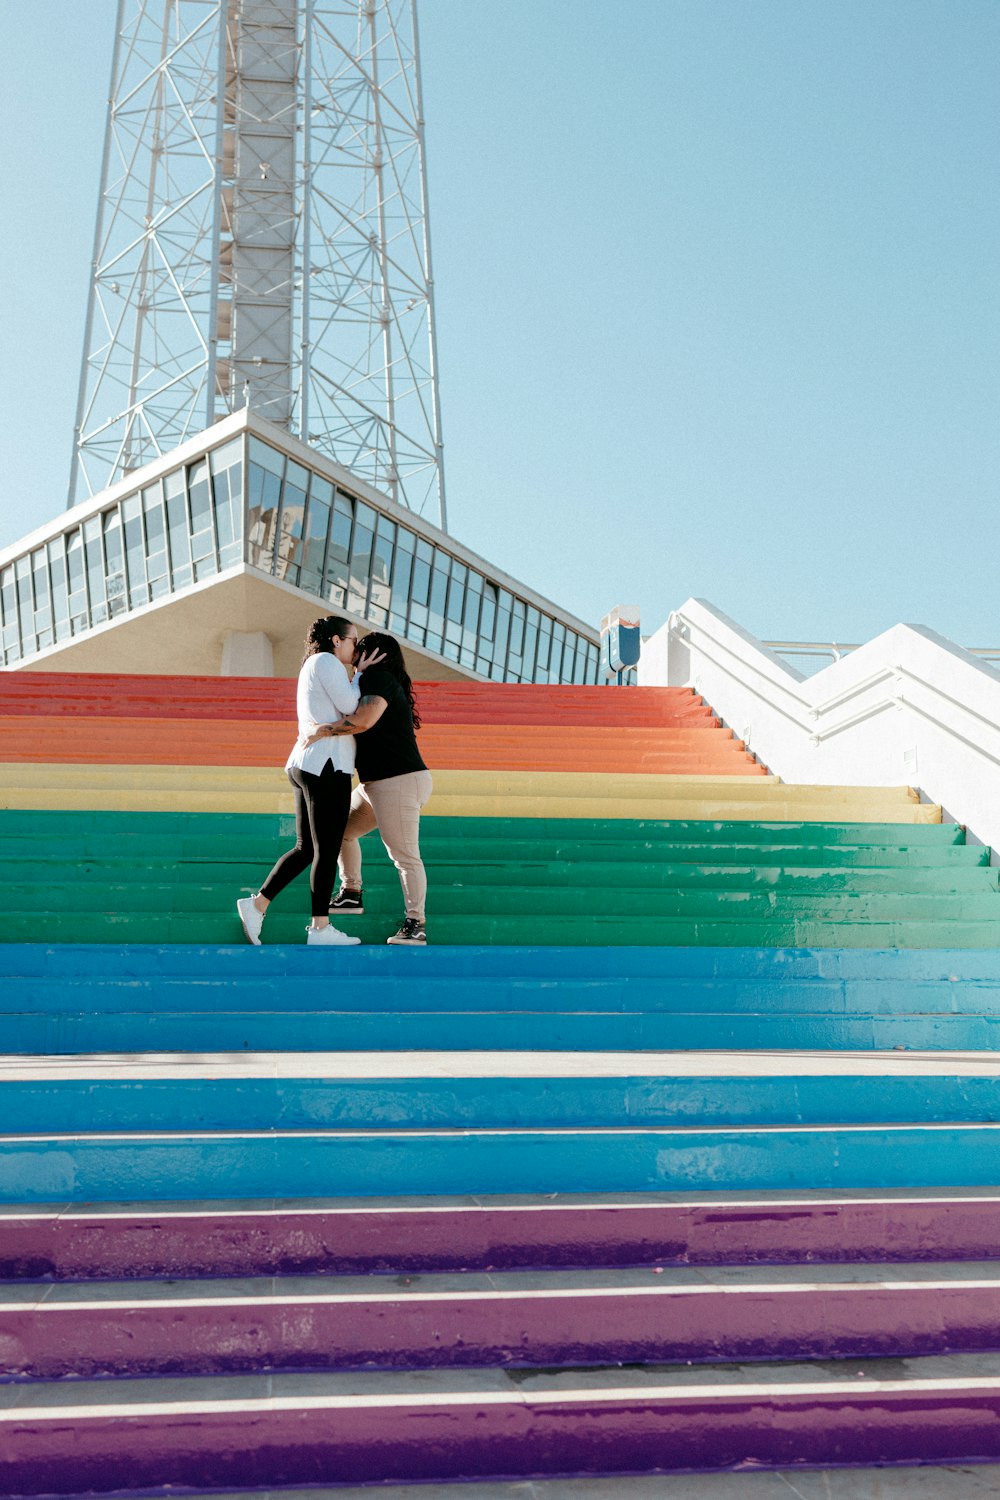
[302,632,432,945]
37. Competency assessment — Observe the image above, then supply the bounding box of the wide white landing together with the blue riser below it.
[0,1052,1000,1134]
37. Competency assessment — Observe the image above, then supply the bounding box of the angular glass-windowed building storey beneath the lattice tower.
[0,414,598,683]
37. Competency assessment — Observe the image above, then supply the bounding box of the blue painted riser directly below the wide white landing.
[4,1058,1000,1136]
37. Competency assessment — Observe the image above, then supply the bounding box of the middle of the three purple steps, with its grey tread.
[0,1262,1000,1380]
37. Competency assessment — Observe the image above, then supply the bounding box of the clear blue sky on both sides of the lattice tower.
[0,0,1000,645]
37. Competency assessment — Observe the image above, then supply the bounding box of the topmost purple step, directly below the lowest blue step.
[0,1188,1000,1281]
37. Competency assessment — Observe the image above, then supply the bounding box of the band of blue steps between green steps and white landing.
[0,944,1000,1053]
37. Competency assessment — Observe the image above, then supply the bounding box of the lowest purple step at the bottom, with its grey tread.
[0,1358,1000,1496]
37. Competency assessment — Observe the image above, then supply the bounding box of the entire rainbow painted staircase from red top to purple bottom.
[0,674,1000,1496]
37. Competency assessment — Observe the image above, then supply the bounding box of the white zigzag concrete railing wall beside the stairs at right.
[639,599,1000,861]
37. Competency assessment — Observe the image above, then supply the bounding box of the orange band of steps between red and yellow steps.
[0,716,763,776]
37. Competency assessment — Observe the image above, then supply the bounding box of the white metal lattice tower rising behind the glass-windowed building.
[70,0,447,527]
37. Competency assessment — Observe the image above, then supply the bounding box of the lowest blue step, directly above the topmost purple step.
[9,1124,1000,1203]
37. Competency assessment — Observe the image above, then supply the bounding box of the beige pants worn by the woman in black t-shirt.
[339,771,433,923]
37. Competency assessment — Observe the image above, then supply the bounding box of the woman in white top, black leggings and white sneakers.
[237,615,381,947]
